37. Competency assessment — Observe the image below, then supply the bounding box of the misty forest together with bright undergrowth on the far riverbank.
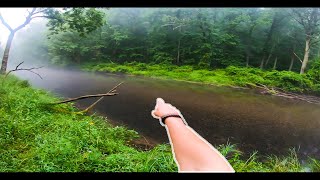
[3,8,320,94]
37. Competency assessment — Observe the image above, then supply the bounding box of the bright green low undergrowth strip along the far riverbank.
[82,62,320,94]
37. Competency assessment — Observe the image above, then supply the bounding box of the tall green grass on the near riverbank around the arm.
[0,76,320,172]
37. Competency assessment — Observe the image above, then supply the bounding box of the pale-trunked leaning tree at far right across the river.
[292,8,320,74]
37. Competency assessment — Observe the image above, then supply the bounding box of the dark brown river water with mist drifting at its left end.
[15,68,320,158]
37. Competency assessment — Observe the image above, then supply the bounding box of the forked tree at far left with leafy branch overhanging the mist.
[0,8,103,74]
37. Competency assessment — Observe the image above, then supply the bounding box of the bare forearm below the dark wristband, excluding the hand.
[166,117,234,172]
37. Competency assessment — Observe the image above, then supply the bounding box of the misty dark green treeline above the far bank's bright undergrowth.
[48,8,320,73]
